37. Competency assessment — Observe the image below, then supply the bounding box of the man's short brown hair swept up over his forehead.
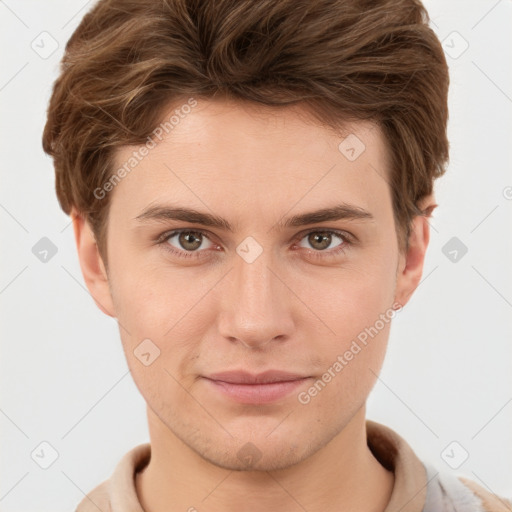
[43,0,449,264]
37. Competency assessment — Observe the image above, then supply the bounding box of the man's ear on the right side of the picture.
[395,194,437,306]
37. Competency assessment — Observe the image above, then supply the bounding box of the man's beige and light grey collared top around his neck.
[75,420,512,512]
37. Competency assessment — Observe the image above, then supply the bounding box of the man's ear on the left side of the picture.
[71,210,116,318]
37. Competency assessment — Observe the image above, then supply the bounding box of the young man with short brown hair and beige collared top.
[43,0,511,512]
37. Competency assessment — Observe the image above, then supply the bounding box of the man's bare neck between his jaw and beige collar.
[135,406,394,512]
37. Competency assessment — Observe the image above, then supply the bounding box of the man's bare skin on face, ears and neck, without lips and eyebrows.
[73,99,434,512]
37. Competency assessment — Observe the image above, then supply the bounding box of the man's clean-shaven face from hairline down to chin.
[76,96,428,470]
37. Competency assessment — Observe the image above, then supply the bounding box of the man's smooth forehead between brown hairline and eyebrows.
[112,100,390,222]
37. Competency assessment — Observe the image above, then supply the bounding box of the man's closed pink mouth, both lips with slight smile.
[203,370,312,404]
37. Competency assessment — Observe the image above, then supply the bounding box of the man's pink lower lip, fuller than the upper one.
[206,378,308,404]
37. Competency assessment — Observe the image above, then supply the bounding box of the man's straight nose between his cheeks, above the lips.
[219,250,294,349]
